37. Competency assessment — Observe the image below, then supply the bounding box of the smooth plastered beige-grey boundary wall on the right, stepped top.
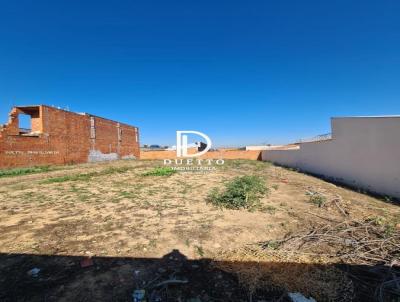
[262,116,400,198]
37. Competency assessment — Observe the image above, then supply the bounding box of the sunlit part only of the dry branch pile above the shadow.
[261,220,400,265]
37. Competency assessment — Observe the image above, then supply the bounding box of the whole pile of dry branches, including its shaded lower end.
[260,219,400,302]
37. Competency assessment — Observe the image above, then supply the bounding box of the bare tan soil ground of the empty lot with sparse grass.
[0,160,400,302]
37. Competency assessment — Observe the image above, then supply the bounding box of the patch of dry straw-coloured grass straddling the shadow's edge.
[215,246,354,301]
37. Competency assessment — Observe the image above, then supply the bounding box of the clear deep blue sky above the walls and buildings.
[0,0,400,146]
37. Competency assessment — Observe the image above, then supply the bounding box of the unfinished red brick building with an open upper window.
[0,105,140,168]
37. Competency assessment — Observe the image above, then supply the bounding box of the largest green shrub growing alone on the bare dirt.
[207,176,268,210]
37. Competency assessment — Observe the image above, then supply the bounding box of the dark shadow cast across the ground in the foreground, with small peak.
[0,250,399,302]
